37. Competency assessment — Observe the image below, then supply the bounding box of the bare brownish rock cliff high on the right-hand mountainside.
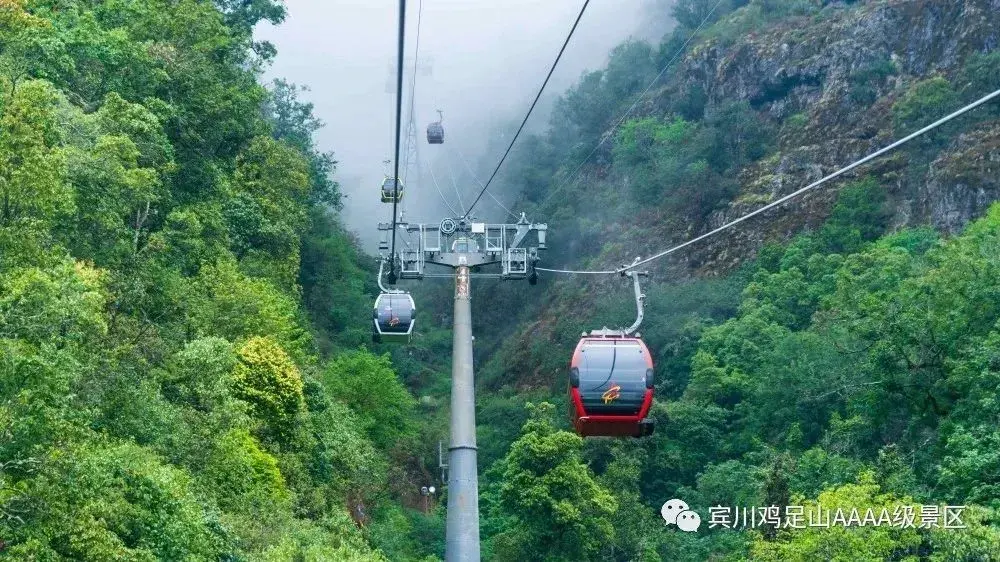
[649,0,1000,272]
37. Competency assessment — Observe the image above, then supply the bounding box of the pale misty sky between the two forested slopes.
[257,0,666,247]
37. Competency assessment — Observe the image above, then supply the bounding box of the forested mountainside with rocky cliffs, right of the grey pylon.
[460,0,1000,561]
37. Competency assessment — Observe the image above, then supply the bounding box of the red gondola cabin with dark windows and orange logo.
[569,332,653,437]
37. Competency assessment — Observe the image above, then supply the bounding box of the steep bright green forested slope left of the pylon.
[0,0,432,561]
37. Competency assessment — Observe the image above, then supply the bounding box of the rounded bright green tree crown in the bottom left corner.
[7,443,225,560]
